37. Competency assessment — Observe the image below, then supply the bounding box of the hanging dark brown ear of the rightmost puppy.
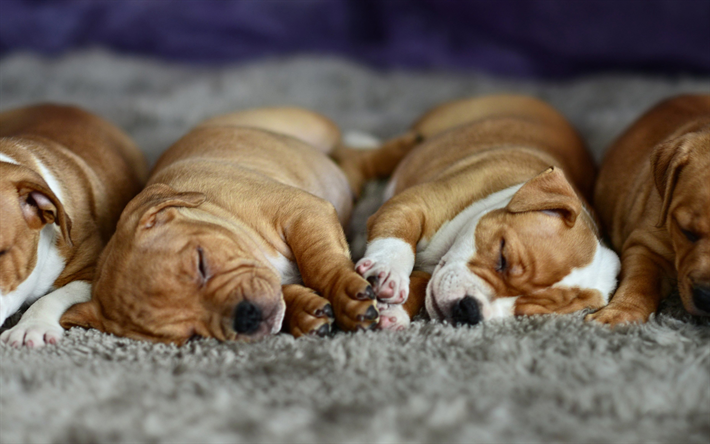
[651,134,690,228]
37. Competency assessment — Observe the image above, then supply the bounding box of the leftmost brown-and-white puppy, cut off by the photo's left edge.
[0,105,147,347]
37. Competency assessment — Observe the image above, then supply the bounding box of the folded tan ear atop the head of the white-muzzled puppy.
[506,167,582,227]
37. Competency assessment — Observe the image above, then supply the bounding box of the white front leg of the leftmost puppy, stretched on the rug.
[0,281,91,348]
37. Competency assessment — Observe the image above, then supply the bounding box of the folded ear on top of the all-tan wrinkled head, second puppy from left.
[131,183,207,228]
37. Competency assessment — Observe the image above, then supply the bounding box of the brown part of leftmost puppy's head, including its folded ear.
[0,162,71,295]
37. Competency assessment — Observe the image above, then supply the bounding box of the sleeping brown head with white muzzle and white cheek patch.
[426,168,619,324]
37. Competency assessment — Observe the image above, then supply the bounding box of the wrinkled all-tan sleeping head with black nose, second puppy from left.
[61,184,285,344]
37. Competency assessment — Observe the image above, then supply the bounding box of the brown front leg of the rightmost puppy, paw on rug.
[585,246,668,325]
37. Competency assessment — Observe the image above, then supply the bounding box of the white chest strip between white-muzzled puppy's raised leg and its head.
[415,184,523,273]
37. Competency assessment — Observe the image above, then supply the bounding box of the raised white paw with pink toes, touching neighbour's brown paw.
[355,238,414,304]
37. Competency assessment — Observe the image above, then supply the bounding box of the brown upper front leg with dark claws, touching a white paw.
[281,198,379,331]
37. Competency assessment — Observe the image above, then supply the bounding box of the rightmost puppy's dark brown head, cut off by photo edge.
[651,124,710,316]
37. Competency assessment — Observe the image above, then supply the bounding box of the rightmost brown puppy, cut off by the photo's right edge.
[588,94,710,325]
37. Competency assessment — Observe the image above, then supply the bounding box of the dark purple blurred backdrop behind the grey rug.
[0,0,710,77]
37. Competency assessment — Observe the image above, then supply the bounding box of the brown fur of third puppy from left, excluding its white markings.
[368,96,604,315]
